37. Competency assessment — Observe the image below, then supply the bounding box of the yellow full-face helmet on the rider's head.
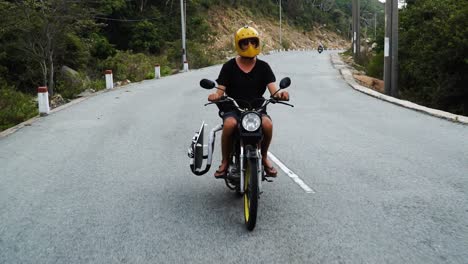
[234,26,260,58]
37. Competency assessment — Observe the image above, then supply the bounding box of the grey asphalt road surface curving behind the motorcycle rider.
[0,52,468,264]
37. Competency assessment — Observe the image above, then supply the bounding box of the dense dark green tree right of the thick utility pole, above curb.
[399,0,468,115]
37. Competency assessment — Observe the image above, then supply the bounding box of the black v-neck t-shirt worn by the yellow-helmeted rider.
[216,58,276,108]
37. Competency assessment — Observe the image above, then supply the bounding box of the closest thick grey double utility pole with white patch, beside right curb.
[384,0,398,97]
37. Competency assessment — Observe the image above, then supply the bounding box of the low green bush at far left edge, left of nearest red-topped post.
[0,86,38,131]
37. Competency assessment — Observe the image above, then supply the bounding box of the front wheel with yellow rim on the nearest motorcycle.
[244,159,259,231]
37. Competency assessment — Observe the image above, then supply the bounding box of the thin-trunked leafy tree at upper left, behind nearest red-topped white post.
[10,0,89,95]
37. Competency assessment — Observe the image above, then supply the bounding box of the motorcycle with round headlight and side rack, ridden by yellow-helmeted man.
[188,77,294,231]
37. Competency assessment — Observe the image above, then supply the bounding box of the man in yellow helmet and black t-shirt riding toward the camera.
[208,26,289,178]
